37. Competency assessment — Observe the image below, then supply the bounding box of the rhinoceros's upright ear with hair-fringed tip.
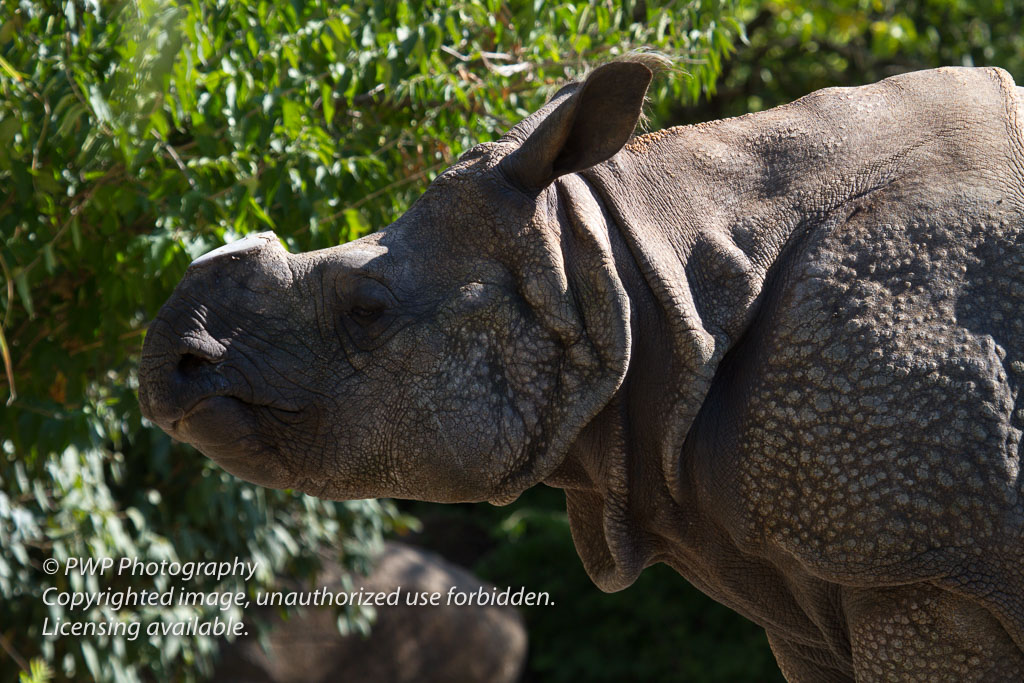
[502,61,653,190]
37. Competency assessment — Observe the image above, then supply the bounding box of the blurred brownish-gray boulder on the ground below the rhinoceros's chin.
[212,543,526,683]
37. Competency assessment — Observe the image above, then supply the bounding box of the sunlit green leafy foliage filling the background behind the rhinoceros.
[0,0,1024,681]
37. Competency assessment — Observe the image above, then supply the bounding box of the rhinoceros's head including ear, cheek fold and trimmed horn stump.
[139,61,651,502]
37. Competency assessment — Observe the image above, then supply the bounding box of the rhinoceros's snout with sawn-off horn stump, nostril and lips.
[138,232,304,488]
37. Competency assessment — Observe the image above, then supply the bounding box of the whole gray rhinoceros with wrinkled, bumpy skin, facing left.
[139,61,1024,682]
